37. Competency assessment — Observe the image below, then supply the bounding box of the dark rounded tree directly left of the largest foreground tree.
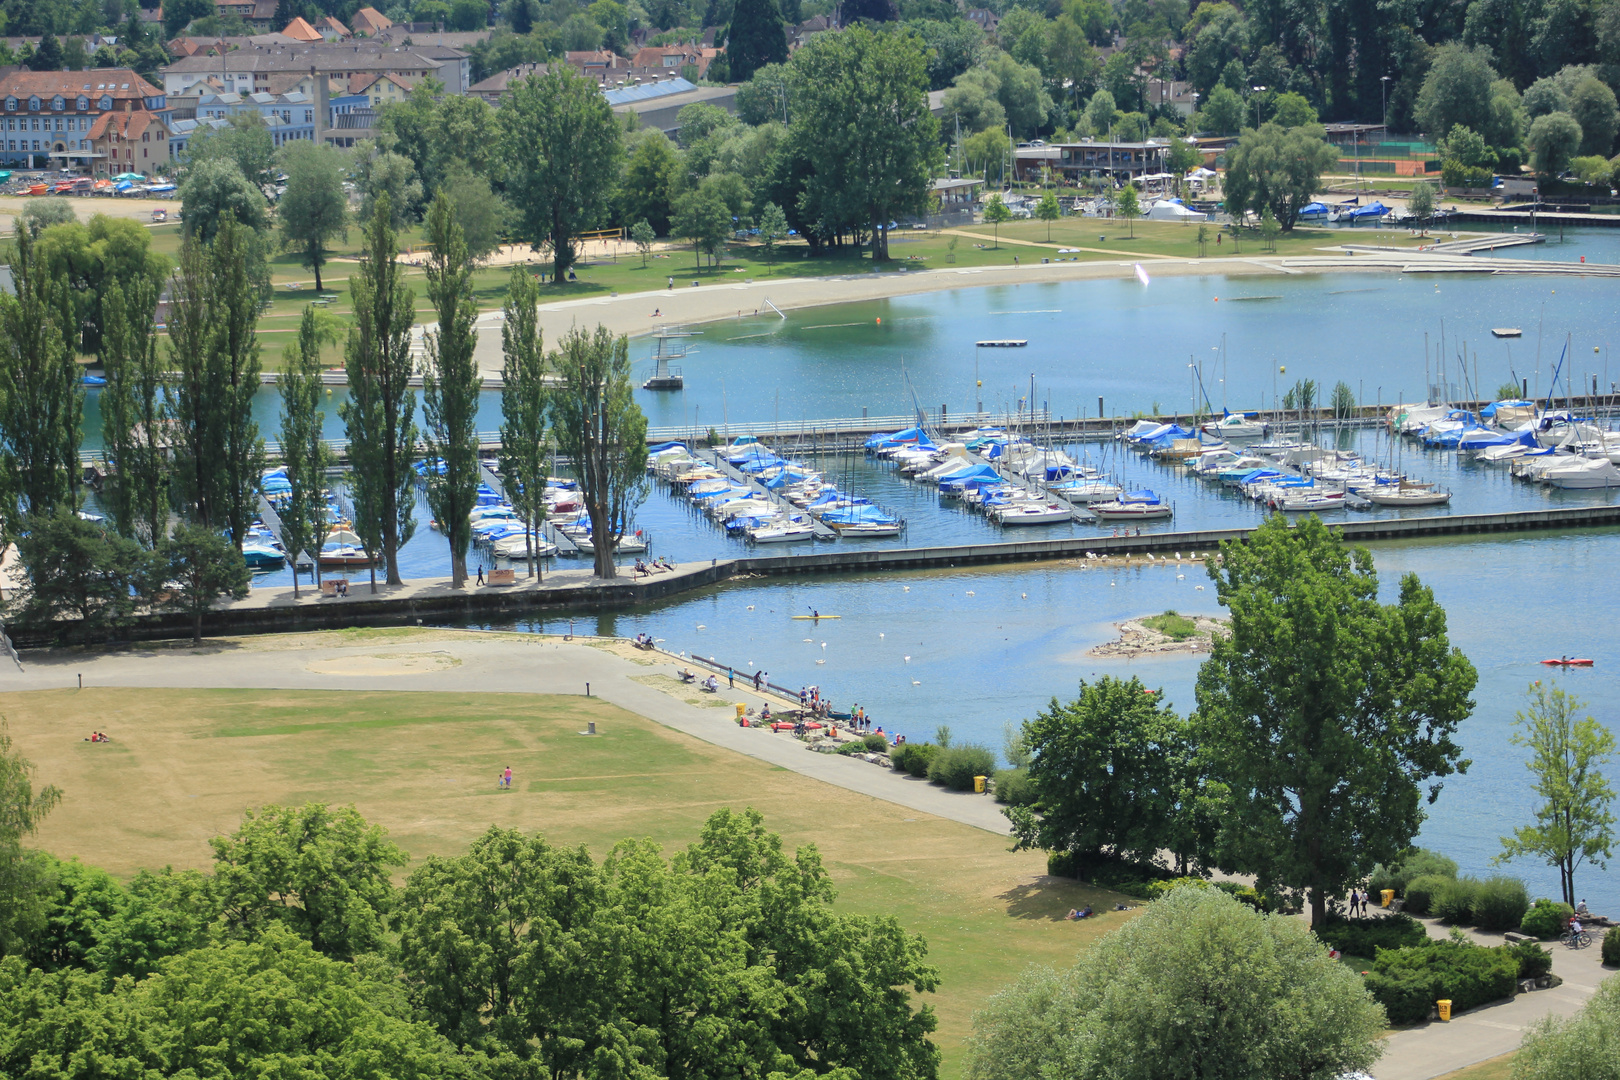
[1003,675,1189,874]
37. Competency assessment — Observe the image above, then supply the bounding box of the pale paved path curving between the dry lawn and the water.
[0,630,1011,836]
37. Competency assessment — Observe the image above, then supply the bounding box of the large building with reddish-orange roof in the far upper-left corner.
[0,68,168,173]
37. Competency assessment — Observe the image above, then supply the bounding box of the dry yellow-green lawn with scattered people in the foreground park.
[0,689,1126,1077]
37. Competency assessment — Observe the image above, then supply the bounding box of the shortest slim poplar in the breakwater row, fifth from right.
[280,308,332,597]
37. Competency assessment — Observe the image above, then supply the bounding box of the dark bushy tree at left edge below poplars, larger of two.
[10,504,149,638]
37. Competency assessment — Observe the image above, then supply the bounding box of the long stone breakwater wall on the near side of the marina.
[19,505,1620,649]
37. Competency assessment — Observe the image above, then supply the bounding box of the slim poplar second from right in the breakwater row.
[501,266,546,578]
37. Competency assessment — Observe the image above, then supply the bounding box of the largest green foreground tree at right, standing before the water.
[1192,515,1477,926]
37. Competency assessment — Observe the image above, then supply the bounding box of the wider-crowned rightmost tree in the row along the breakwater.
[551,325,646,578]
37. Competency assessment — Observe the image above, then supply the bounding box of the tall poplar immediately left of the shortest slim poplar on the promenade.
[209,214,264,552]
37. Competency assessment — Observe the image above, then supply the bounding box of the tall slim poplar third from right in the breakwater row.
[423,189,483,589]
